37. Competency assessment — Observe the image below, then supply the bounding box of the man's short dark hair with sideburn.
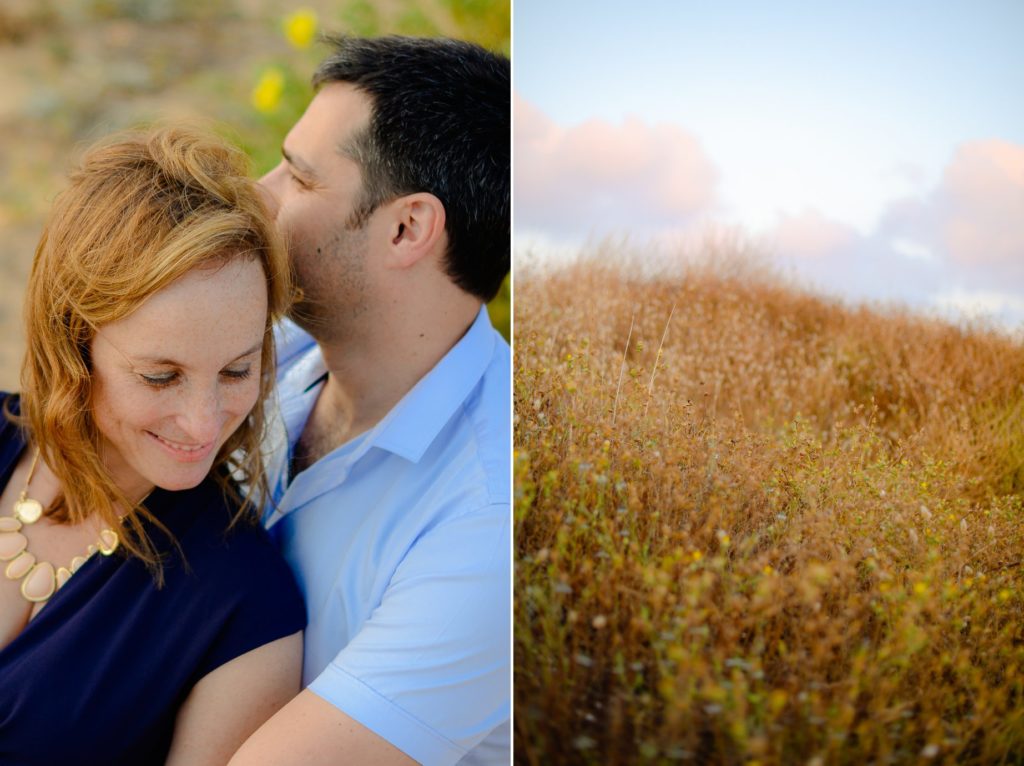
[312,36,512,301]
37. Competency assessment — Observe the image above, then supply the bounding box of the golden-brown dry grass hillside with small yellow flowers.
[514,249,1024,766]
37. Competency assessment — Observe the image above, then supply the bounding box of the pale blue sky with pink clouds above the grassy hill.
[513,0,1024,325]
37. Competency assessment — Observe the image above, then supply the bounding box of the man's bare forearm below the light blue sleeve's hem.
[228,689,416,766]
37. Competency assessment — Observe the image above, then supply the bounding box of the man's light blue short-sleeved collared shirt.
[266,309,512,764]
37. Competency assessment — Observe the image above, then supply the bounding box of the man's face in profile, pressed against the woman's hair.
[260,83,372,341]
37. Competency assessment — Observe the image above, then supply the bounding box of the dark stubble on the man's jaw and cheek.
[289,218,372,343]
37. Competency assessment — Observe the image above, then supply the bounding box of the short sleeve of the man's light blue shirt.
[309,503,511,766]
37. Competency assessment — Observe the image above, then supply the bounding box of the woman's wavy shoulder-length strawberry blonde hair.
[18,127,291,579]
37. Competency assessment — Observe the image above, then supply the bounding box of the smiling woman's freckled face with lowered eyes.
[91,257,267,499]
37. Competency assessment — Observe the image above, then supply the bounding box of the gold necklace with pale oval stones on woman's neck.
[0,450,120,603]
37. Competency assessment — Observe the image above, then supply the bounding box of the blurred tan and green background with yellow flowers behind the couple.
[0,0,510,390]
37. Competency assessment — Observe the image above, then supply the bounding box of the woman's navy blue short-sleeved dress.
[0,395,306,766]
